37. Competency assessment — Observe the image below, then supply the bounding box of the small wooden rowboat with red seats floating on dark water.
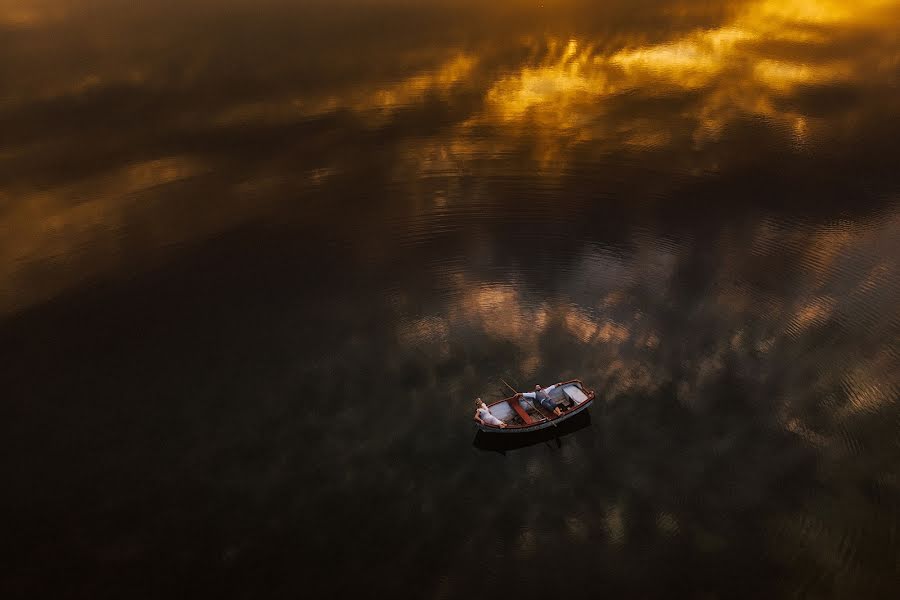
[476,379,594,433]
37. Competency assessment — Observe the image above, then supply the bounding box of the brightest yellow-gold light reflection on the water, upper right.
[474,0,900,159]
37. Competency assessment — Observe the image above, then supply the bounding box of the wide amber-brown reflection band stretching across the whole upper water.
[0,0,900,312]
